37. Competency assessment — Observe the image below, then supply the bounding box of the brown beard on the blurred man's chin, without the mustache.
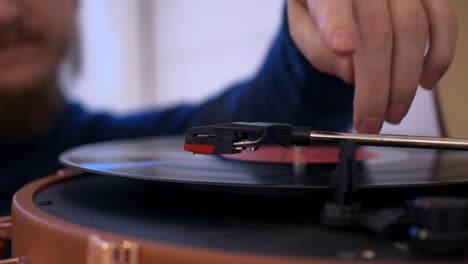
[0,78,64,141]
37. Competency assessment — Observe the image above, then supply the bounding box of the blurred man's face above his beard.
[0,0,77,93]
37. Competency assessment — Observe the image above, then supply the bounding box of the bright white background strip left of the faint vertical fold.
[69,0,151,112]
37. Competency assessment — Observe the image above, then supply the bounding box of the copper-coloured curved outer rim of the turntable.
[6,170,460,264]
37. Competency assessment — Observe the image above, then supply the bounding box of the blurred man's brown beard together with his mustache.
[0,15,70,142]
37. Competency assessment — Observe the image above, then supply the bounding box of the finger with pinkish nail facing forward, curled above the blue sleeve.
[307,0,358,55]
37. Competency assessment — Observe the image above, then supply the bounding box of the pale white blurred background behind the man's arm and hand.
[67,0,440,136]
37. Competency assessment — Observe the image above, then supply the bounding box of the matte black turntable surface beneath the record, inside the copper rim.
[34,173,468,263]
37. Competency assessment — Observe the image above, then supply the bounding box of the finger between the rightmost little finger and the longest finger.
[386,0,429,124]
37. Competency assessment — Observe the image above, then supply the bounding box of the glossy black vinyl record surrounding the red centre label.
[60,137,468,193]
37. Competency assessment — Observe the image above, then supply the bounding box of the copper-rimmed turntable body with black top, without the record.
[8,170,464,264]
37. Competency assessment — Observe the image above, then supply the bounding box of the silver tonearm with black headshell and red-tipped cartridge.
[184,122,468,154]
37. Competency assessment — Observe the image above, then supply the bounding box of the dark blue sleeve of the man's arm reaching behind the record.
[85,7,354,141]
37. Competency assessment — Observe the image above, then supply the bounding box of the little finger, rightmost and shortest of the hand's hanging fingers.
[421,0,458,89]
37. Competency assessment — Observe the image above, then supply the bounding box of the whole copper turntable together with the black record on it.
[3,137,468,264]
